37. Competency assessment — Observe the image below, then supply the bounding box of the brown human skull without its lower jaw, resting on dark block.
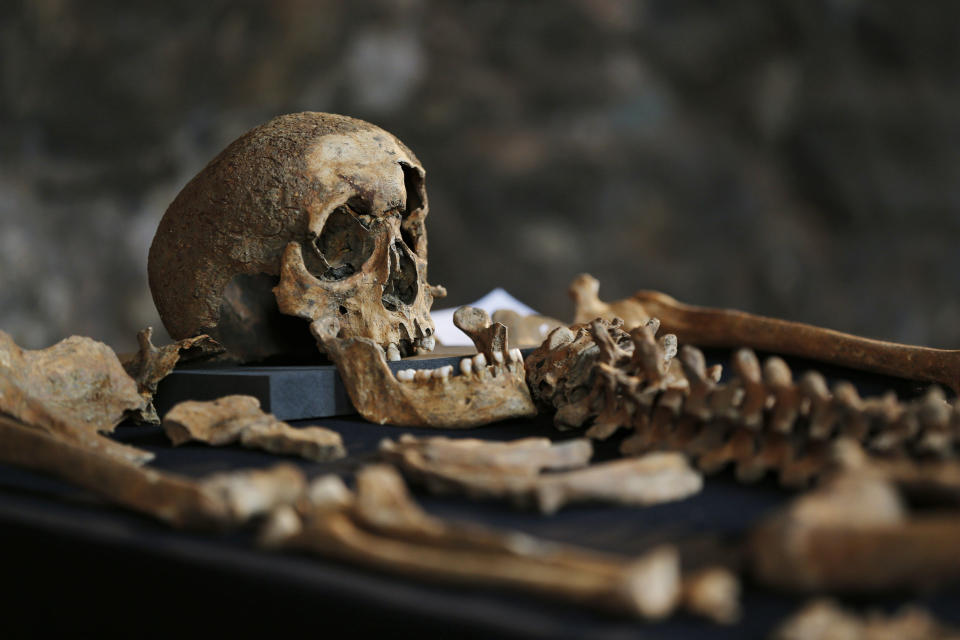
[148,112,444,361]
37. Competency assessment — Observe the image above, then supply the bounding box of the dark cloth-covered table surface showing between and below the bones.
[0,352,960,638]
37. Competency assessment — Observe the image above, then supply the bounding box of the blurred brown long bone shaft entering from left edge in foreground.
[0,416,230,529]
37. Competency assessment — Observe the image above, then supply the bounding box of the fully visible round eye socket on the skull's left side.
[307,205,374,280]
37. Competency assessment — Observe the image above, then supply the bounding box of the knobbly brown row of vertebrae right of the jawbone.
[526,319,960,486]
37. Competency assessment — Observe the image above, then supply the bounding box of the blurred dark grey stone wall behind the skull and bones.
[0,0,960,350]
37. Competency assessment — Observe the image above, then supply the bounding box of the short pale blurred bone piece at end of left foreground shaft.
[200,464,307,522]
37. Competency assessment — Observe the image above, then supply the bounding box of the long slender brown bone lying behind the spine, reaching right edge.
[570,274,960,393]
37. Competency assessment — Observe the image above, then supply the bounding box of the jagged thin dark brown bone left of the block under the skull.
[121,327,223,424]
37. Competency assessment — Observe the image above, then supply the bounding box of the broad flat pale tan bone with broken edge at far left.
[0,331,153,464]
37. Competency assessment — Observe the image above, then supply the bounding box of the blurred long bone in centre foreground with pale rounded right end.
[267,465,681,618]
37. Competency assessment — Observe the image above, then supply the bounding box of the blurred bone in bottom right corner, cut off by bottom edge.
[772,600,960,640]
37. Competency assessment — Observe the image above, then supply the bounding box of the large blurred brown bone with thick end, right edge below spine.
[750,448,960,592]
